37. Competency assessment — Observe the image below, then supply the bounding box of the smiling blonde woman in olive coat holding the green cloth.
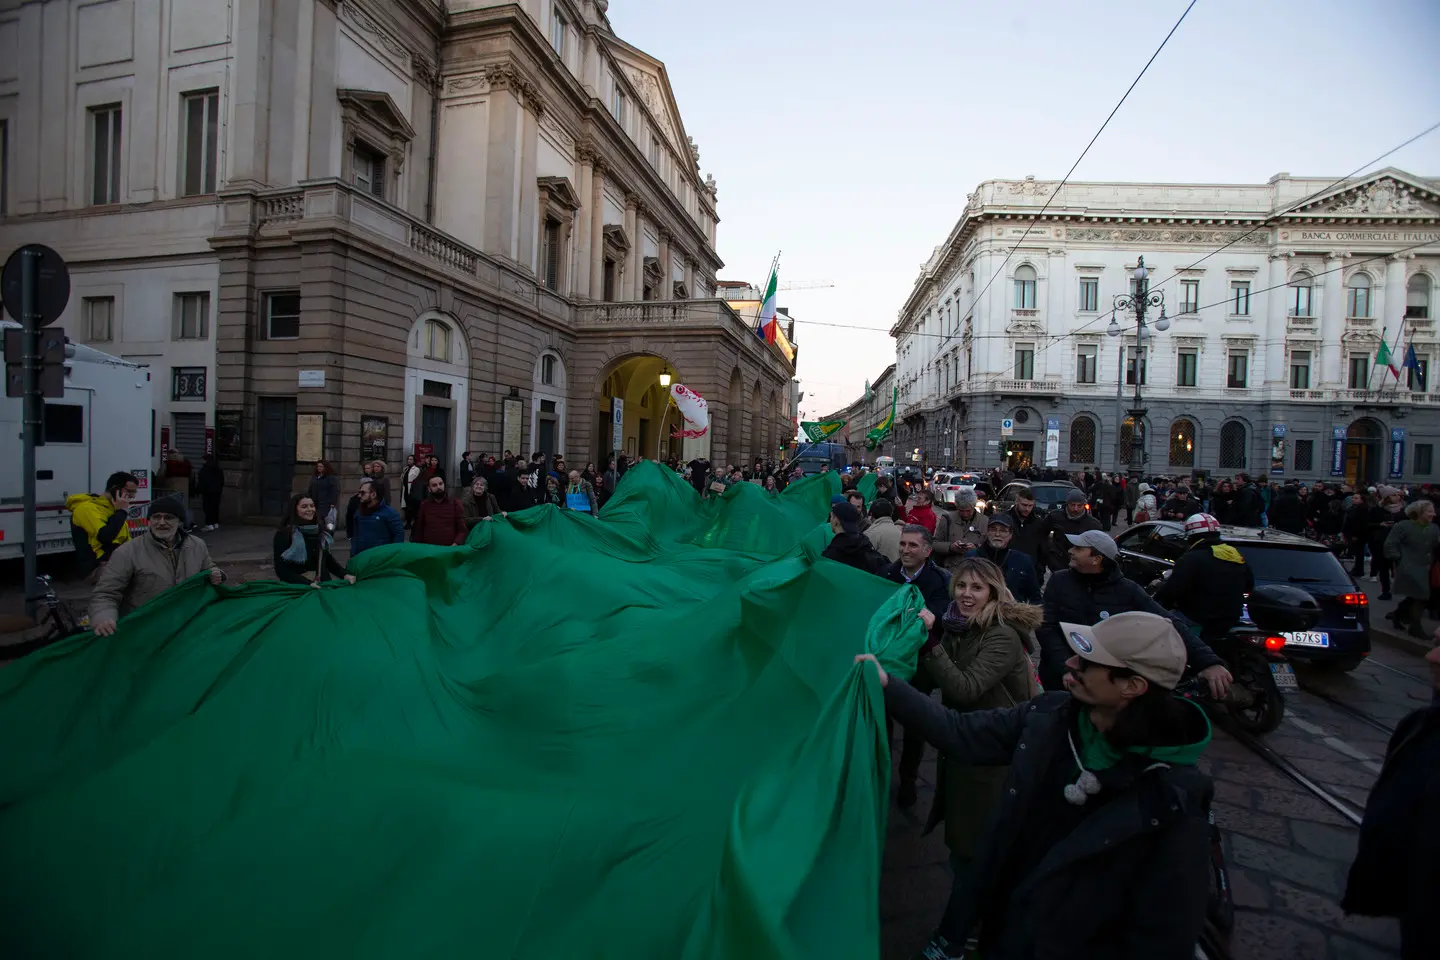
[920,557,1043,946]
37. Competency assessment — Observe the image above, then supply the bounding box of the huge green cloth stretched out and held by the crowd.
[0,465,923,960]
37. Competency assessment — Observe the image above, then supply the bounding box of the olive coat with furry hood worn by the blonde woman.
[920,600,1041,861]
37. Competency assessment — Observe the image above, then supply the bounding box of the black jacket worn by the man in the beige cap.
[886,687,1212,960]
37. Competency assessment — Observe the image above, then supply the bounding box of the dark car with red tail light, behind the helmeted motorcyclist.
[1115,520,1369,671]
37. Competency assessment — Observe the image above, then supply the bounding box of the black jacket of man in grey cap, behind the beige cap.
[1035,564,1223,691]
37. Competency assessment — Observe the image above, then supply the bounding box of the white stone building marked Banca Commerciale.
[891,168,1440,482]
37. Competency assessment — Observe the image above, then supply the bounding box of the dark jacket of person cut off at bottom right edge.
[1341,702,1440,960]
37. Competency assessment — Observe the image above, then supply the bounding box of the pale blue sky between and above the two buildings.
[609,0,1440,416]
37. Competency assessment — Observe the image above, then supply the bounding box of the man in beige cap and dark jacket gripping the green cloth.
[855,612,1212,960]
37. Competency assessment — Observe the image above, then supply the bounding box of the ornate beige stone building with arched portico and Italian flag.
[0,0,793,514]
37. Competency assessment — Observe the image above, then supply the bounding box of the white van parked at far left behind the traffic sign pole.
[0,333,154,560]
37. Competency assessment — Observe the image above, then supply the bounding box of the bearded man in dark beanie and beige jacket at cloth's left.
[89,497,225,636]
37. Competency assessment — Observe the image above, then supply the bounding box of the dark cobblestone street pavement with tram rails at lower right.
[880,646,1431,960]
